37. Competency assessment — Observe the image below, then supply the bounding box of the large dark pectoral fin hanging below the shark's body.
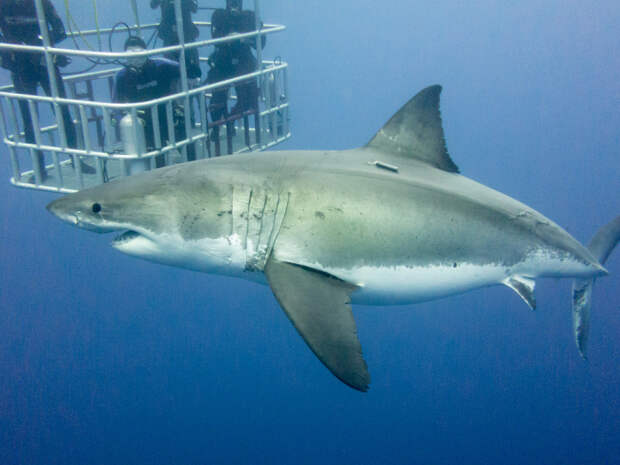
[265,257,370,391]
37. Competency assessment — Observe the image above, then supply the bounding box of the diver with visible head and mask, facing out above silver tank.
[112,36,196,168]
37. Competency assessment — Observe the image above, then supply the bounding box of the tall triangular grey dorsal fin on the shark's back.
[366,85,459,173]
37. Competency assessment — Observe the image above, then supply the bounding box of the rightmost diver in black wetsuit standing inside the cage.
[207,0,265,139]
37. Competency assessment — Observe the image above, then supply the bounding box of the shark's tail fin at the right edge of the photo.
[573,216,620,359]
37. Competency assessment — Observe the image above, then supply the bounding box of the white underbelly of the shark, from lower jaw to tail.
[114,229,591,305]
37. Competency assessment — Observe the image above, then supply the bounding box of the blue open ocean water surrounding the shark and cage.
[0,0,620,465]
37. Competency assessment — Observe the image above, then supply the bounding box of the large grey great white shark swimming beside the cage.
[48,86,620,391]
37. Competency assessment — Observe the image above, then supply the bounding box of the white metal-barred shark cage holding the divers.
[0,0,291,193]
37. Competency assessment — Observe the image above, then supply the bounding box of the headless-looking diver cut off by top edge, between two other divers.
[151,0,202,79]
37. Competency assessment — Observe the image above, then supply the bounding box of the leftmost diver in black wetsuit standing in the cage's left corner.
[0,0,95,178]
